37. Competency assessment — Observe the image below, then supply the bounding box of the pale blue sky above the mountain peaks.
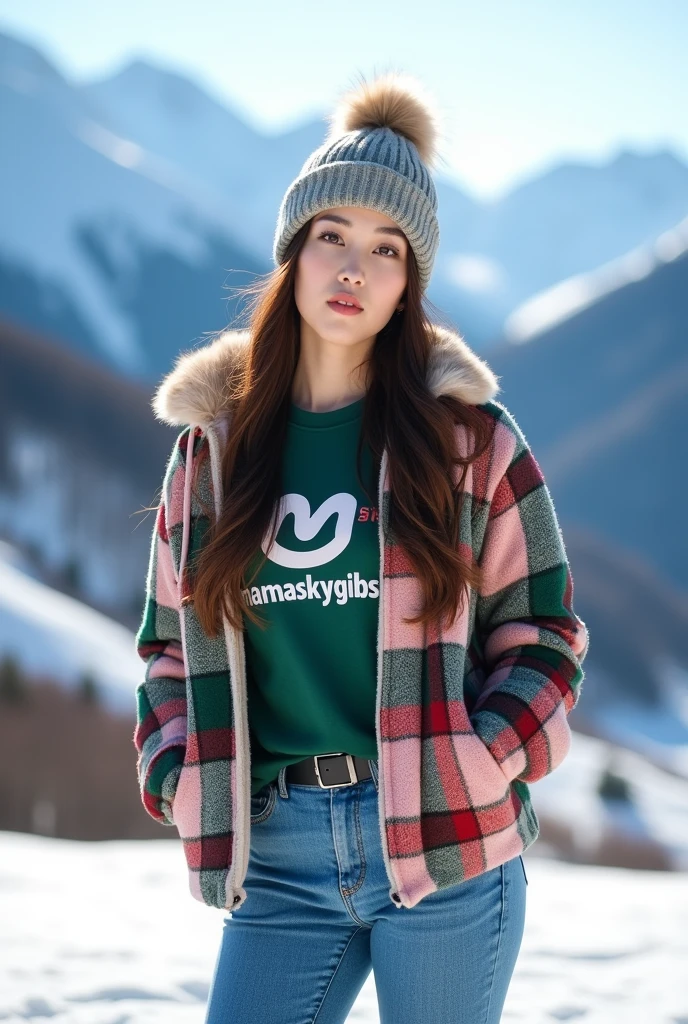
[0,0,688,199]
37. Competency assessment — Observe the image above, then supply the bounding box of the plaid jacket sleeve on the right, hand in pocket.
[471,408,589,782]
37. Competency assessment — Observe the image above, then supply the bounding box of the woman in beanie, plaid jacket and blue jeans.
[134,74,588,1024]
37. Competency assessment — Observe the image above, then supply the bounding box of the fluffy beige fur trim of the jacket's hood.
[153,325,500,430]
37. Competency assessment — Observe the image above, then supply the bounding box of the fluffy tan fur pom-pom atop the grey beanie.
[327,71,440,167]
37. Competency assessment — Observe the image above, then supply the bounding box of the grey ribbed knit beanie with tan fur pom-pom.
[272,72,439,292]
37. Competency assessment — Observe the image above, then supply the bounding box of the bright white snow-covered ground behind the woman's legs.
[0,831,688,1024]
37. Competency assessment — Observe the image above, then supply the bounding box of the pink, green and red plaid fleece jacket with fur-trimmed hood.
[133,327,589,909]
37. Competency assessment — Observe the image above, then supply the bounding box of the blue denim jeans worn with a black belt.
[205,761,527,1024]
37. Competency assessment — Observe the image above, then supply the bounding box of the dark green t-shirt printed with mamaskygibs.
[244,398,380,794]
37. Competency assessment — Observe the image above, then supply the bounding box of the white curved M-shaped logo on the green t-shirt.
[261,490,357,569]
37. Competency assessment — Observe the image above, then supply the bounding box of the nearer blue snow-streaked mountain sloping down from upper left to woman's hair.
[0,34,266,380]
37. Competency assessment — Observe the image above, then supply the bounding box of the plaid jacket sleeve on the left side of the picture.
[133,432,186,825]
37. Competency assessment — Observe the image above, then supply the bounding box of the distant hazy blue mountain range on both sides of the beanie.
[0,34,688,382]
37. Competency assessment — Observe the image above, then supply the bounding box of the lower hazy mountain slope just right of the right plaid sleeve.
[562,521,688,778]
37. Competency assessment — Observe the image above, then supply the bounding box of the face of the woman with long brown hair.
[294,206,409,345]
